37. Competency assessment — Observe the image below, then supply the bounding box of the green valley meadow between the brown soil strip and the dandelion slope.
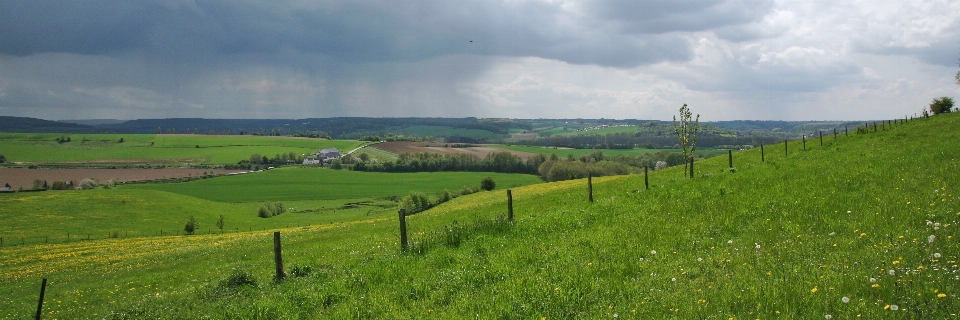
[0,168,543,246]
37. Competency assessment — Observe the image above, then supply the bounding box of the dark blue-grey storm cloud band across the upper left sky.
[0,0,764,67]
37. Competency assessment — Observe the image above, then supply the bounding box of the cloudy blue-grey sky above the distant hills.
[0,0,960,121]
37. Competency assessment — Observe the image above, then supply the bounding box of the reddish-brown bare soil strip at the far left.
[0,168,247,190]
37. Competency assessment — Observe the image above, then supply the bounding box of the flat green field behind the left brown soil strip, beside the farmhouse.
[0,133,362,165]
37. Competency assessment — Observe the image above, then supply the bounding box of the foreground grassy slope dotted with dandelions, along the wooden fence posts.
[0,115,960,319]
